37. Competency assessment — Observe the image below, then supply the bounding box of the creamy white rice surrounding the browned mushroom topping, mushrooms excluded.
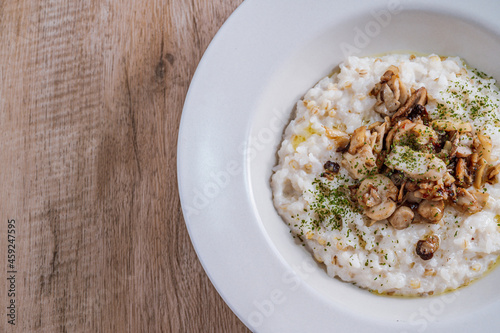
[271,55,500,295]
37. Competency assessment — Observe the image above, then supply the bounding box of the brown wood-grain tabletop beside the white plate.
[0,0,247,332]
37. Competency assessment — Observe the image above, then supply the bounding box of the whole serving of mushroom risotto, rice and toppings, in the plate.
[271,55,500,295]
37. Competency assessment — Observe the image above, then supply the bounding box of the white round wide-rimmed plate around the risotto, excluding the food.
[178,0,500,332]
